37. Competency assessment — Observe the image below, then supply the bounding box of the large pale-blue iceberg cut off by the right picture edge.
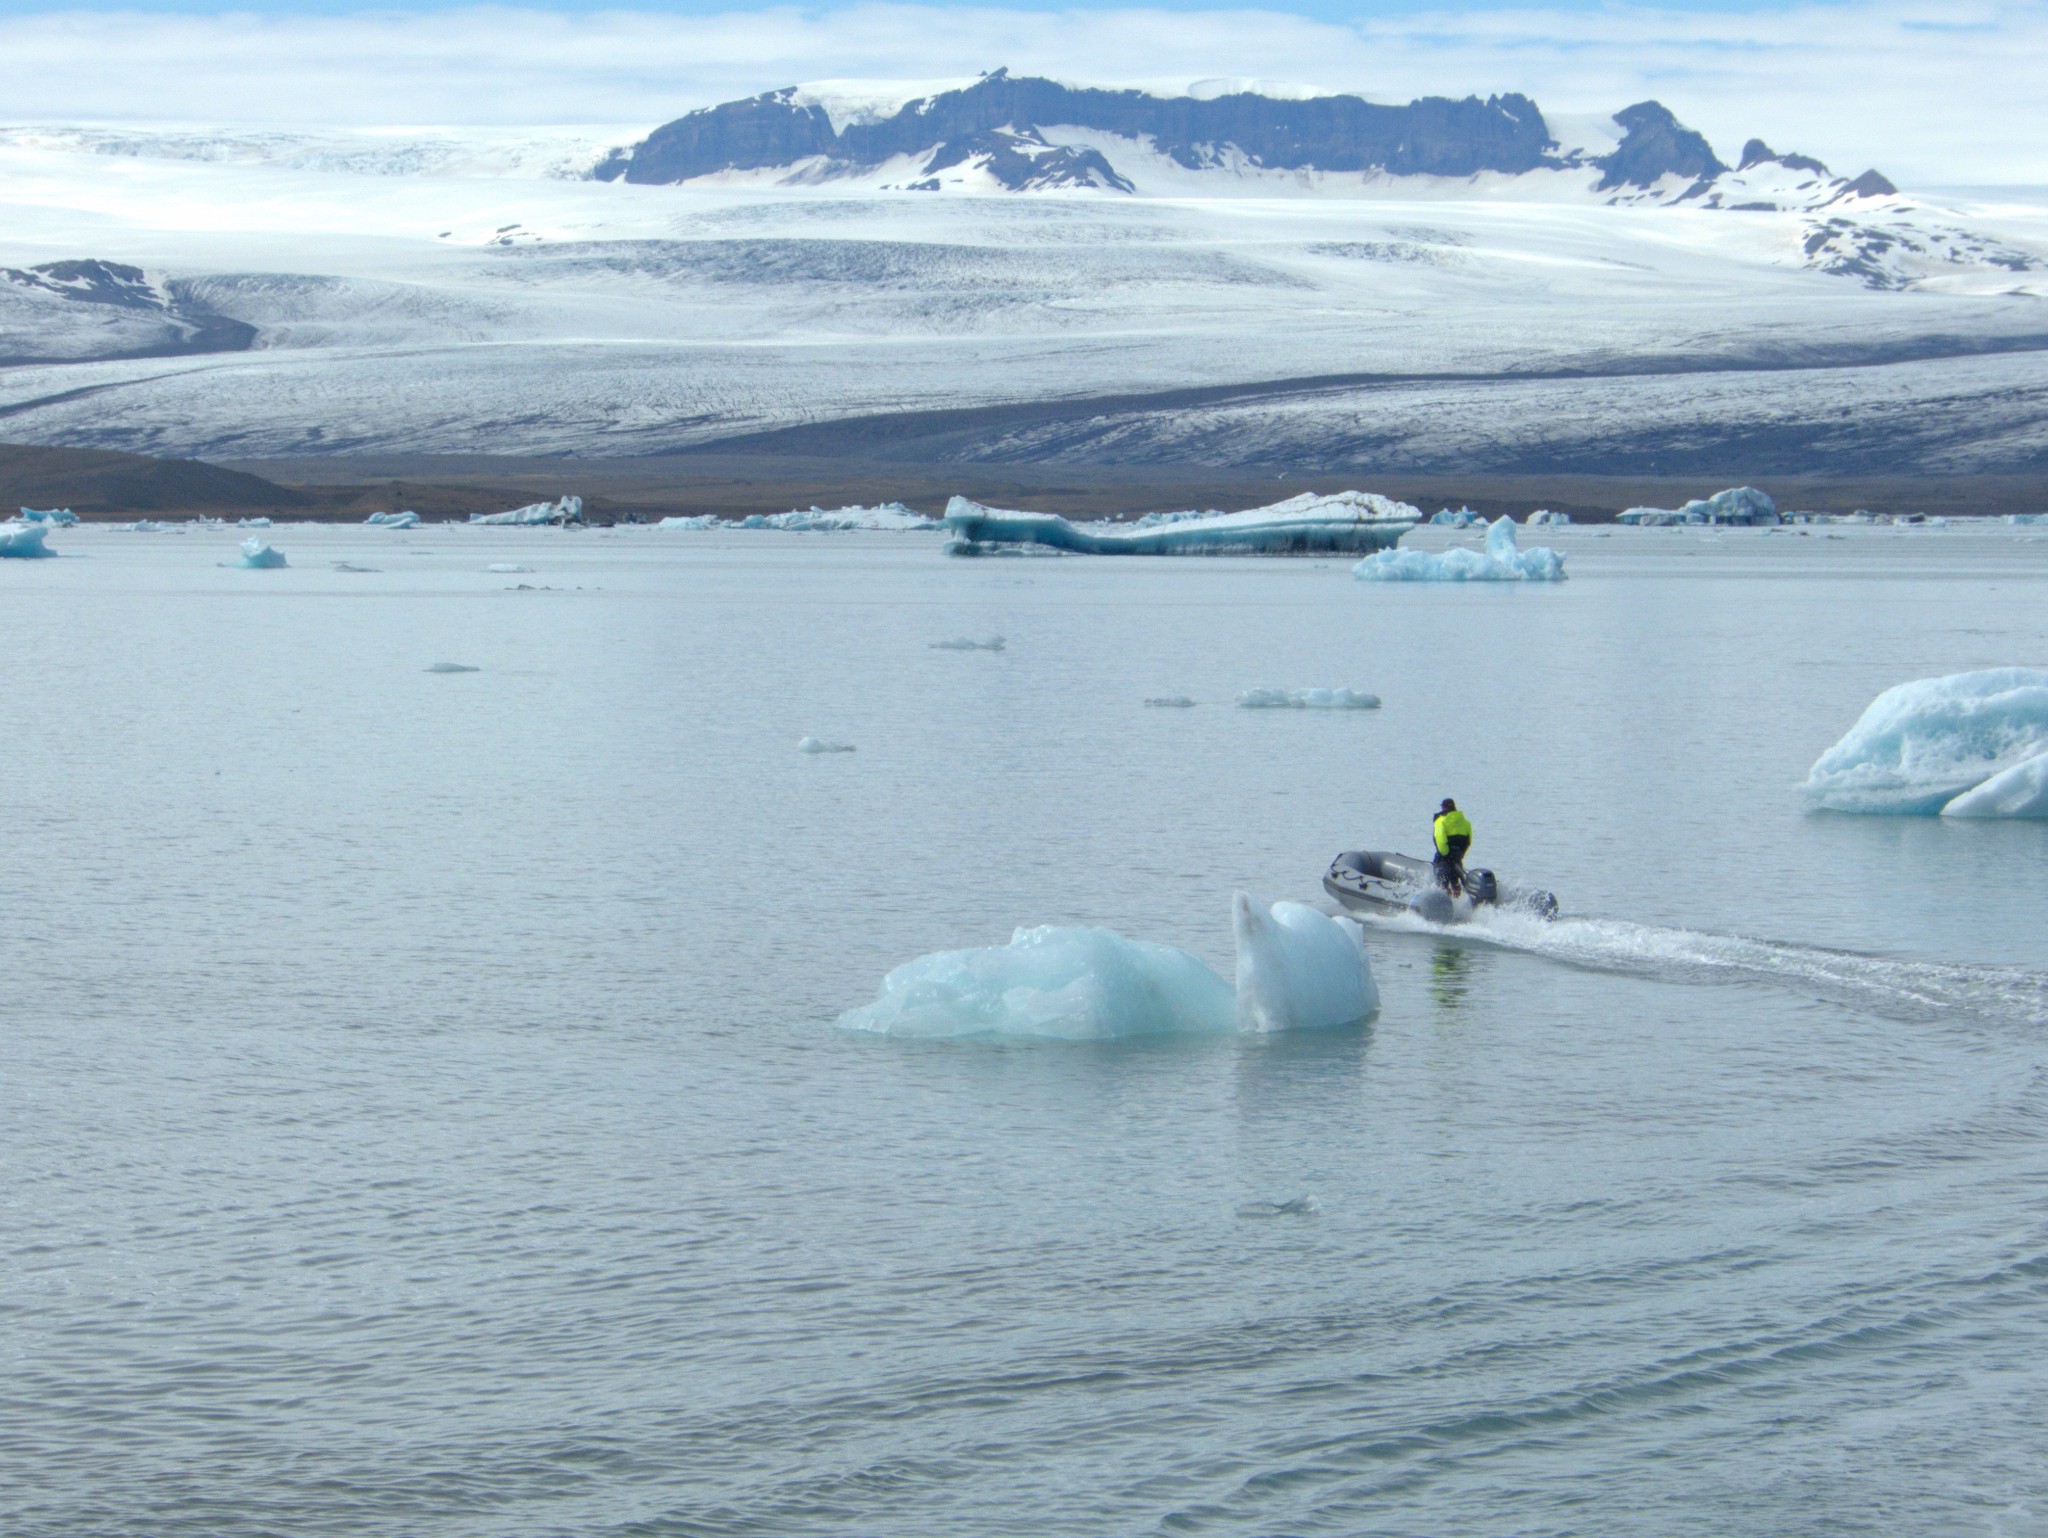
[1806,668,2048,817]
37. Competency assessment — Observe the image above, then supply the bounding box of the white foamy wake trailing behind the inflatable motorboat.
[1354,911,2048,1026]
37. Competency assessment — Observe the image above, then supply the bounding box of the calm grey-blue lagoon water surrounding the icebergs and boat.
[0,526,2048,1538]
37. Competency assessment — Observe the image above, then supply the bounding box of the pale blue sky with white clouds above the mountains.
[0,0,2048,186]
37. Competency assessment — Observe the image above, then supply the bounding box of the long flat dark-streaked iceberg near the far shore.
[946,492,1421,555]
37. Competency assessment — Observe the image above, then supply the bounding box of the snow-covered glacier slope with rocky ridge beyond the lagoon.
[0,74,2048,467]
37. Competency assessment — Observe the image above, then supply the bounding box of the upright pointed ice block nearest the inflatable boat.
[1231,893,1380,1030]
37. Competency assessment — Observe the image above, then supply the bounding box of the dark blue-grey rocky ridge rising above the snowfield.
[592,70,1761,190]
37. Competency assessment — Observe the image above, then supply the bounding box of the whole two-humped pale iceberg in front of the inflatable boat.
[838,893,1378,1040]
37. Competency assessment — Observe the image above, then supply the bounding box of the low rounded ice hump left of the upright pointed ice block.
[840,926,1235,1040]
